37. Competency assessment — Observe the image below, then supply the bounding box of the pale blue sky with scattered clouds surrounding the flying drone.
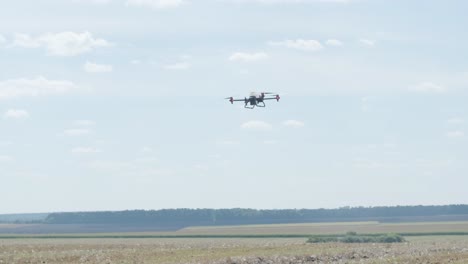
[0,0,468,213]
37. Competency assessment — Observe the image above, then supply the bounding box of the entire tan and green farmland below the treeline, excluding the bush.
[0,222,468,264]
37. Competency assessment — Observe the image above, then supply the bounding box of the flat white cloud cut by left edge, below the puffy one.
[0,76,77,100]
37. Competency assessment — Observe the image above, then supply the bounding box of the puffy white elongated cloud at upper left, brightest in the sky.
[13,31,112,57]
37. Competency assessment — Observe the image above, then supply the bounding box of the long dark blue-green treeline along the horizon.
[44,205,468,228]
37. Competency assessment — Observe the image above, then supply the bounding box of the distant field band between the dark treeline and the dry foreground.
[0,222,468,238]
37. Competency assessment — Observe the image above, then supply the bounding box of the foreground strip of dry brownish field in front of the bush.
[0,236,468,264]
